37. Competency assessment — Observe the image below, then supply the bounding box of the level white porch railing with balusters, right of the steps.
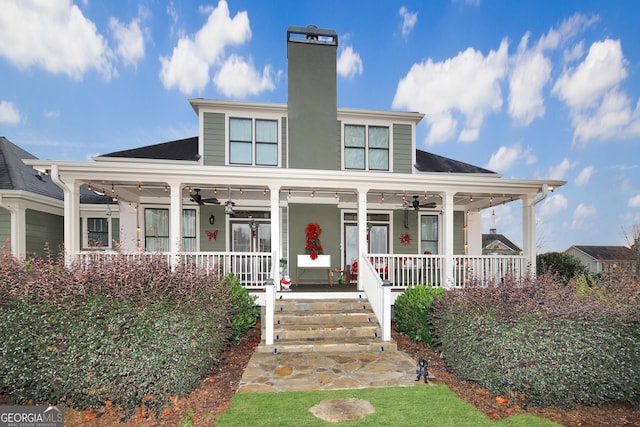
[365,254,529,289]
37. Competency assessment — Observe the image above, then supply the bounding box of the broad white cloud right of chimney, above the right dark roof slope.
[392,40,508,144]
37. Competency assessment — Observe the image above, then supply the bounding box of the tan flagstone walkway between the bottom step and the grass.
[238,351,418,392]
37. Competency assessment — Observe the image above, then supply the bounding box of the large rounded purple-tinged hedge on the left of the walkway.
[0,249,238,420]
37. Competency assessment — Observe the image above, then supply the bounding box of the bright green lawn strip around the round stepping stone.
[216,384,558,427]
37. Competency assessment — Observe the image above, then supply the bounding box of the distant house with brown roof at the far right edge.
[564,245,640,274]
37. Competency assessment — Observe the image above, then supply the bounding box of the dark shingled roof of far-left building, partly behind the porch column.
[0,136,114,204]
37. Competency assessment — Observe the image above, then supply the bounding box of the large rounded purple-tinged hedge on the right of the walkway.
[434,275,640,407]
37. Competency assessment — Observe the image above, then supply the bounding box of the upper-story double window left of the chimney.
[229,117,278,166]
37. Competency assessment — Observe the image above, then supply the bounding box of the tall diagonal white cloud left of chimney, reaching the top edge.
[160,0,251,95]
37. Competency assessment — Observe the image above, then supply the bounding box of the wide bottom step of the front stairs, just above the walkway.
[256,337,398,353]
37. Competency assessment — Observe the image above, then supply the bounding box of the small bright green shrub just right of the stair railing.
[394,285,444,347]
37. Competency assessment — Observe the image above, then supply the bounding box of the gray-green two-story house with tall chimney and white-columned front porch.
[13,26,565,341]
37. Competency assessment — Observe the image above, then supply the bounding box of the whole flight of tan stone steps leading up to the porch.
[256,298,397,353]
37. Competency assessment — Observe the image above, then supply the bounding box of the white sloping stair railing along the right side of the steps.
[358,254,391,341]
